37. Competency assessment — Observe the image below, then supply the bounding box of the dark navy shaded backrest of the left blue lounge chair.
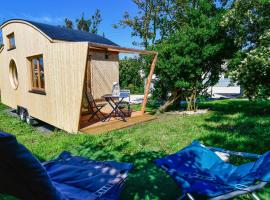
[0,132,64,200]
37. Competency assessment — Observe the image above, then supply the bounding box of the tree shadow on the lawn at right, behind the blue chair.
[199,100,270,199]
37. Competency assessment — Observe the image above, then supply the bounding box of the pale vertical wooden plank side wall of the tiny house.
[0,22,88,132]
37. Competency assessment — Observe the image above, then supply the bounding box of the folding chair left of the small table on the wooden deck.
[85,91,107,121]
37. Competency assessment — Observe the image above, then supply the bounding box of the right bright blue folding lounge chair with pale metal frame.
[155,141,270,200]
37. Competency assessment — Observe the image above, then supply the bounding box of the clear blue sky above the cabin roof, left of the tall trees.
[0,0,137,47]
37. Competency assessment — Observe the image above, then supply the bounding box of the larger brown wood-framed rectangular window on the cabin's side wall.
[28,55,45,93]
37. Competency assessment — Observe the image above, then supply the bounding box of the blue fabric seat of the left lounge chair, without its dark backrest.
[44,152,132,200]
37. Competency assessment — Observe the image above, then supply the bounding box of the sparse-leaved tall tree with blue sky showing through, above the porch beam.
[113,0,231,48]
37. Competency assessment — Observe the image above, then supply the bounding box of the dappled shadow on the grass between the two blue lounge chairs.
[73,140,181,200]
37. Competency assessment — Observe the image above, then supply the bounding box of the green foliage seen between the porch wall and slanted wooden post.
[119,57,144,93]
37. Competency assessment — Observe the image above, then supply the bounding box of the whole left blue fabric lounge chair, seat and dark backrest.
[0,132,132,200]
